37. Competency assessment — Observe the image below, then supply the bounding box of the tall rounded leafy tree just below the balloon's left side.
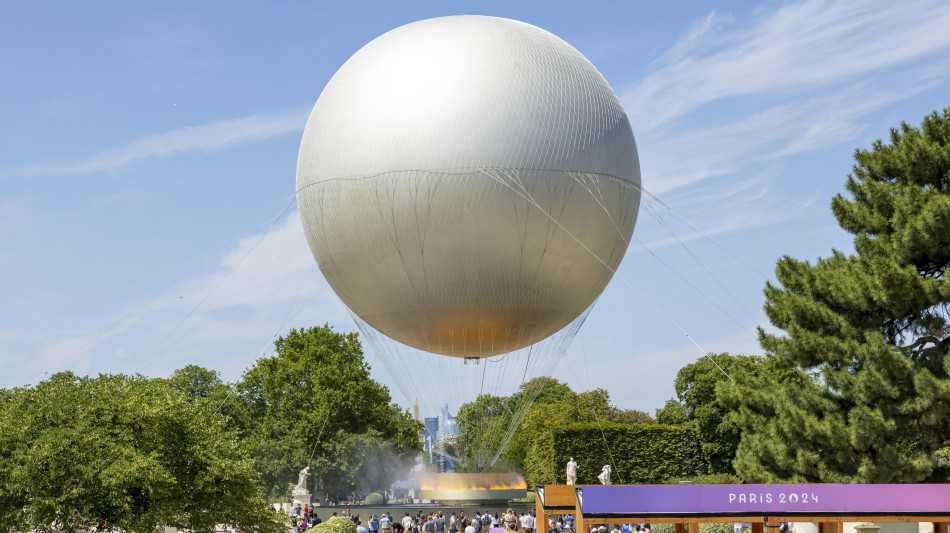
[232,326,422,497]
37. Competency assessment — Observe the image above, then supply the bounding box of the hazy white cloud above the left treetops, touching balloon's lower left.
[0,209,352,387]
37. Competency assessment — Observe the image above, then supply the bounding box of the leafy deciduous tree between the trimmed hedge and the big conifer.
[664,353,809,474]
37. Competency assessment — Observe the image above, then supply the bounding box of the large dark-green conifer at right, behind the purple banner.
[731,109,950,483]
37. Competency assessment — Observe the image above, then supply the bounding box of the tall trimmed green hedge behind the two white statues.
[553,424,708,484]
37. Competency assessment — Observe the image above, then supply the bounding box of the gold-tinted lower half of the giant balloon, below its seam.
[297,169,640,358]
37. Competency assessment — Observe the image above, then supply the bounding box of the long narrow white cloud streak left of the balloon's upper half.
[19,111,307,176]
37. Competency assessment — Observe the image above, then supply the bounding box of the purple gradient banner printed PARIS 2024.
[581,484,950,515]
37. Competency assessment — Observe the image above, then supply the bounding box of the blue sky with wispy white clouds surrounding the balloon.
[0,0,950,414]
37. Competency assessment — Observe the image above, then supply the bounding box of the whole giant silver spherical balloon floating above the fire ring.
[297,16,640,357]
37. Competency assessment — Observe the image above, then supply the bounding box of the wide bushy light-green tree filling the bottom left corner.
[0,372,282,533]
